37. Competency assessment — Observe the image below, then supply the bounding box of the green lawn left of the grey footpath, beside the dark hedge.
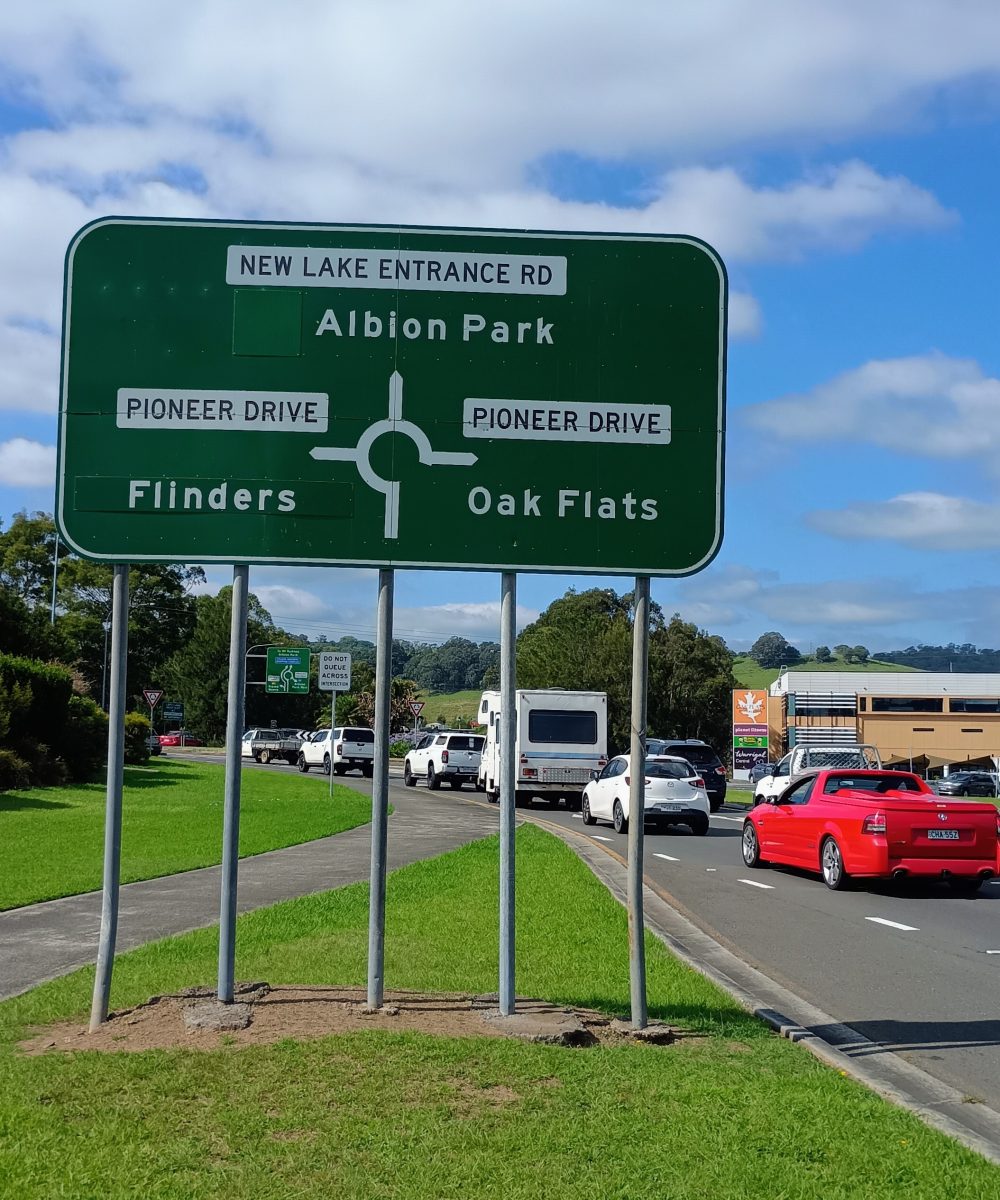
[0,758,371,910]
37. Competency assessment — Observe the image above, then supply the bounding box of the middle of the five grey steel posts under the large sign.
[364,569,395,1009]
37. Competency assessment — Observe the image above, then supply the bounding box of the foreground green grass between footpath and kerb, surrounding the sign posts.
[0,826,1000,1200]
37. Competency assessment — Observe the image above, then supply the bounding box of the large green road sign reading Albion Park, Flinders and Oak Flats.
[56,218,726,575]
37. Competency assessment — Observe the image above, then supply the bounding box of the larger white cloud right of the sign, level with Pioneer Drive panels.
[743,354,1000,458]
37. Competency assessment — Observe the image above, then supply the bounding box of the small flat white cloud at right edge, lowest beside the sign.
[807,492,1000,550]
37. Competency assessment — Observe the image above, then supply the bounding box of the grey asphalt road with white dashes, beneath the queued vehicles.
[130,754,1000,1111]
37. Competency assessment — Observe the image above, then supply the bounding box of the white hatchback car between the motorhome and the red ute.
[583,754,711,836]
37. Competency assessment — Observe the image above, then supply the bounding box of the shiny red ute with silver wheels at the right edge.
[743,769,1000,890]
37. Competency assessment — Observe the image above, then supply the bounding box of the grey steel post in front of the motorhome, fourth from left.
[499,571,517,1016]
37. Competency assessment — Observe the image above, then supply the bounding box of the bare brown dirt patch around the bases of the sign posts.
[20,983,676,1055]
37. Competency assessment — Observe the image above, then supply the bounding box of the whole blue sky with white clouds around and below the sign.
[0,0,1000,649]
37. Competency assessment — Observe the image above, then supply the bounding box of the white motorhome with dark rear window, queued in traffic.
[479,688,607,811]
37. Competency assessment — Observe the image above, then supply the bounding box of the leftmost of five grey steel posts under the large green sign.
[90,563,128,1032]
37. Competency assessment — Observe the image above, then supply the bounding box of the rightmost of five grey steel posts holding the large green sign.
[628,575,649,1030]
